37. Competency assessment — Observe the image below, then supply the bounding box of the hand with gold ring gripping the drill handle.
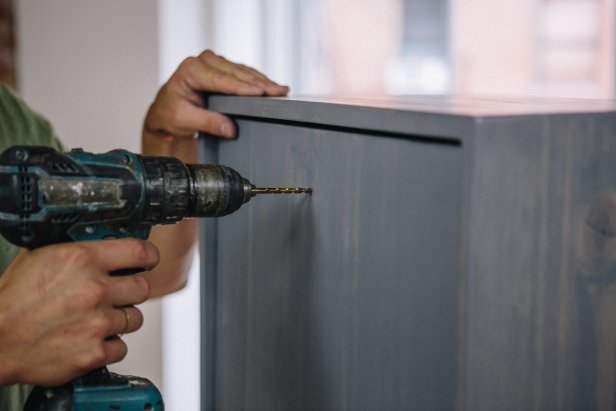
[0,239,159,386]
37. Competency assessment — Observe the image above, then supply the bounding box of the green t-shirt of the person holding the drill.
[0,84,63,411]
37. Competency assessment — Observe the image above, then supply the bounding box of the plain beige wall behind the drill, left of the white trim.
[16,0,163,387]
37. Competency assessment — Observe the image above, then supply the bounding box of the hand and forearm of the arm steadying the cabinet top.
[142,50,289,296]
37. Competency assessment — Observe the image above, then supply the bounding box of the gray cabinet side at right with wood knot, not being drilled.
[465,114,616,410]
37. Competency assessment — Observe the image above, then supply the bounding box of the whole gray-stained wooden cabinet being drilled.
[201,96,616,410]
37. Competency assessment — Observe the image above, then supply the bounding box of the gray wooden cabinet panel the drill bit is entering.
[215,120,462,410]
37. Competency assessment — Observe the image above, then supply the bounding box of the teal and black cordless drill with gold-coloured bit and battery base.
[0,146,312,411]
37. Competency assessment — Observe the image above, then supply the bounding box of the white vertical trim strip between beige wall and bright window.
[158,0,212,411]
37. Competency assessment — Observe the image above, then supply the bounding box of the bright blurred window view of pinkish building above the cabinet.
[213,0,616,98]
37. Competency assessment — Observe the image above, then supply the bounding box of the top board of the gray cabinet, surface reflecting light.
[208,95,616,140]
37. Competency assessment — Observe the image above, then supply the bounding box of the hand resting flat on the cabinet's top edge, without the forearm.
[144,50,289,143]
